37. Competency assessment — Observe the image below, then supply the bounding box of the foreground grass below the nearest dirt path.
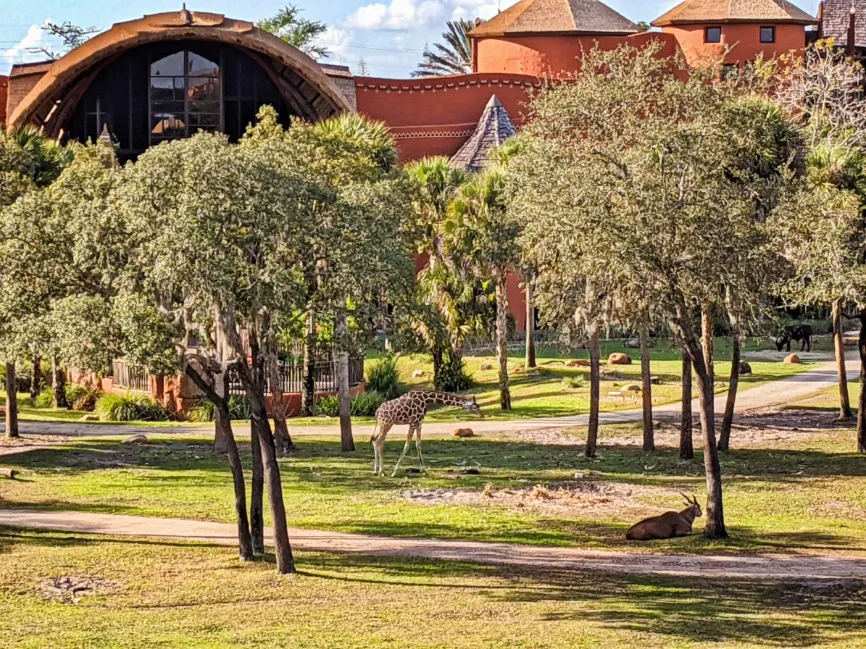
[0,528,866,649]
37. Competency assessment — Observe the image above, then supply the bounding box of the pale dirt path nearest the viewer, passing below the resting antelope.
[0,509,866,582]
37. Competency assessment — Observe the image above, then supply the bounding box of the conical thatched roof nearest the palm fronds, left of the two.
[469,0,638,37]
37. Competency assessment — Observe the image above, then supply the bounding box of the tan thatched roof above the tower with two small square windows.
[652,0,818,27]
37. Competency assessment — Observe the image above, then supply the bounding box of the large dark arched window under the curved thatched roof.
[66,41,295,159]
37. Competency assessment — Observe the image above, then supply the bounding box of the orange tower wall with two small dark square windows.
[663,23,806,65]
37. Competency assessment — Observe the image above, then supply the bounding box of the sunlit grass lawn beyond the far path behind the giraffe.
[0,338,809,428]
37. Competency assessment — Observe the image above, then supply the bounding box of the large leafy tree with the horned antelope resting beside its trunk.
[513,44,796,538]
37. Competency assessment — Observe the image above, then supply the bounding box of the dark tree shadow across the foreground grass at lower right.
[302,555,866,647]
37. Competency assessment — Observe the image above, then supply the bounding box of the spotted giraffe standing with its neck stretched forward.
[370,390,484,478]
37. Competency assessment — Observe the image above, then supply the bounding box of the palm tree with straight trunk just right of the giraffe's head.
[442,167,520,410]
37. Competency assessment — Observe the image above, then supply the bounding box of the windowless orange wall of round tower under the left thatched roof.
[475,32,677,77]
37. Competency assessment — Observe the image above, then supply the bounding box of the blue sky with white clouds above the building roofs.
[0,0,818,77]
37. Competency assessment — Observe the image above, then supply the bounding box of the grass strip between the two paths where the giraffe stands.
[0,417,866,553]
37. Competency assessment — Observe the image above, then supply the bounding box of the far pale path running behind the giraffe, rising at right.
[0,360,859,440]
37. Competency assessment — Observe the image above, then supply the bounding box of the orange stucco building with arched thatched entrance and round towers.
[0,0,816,350]
